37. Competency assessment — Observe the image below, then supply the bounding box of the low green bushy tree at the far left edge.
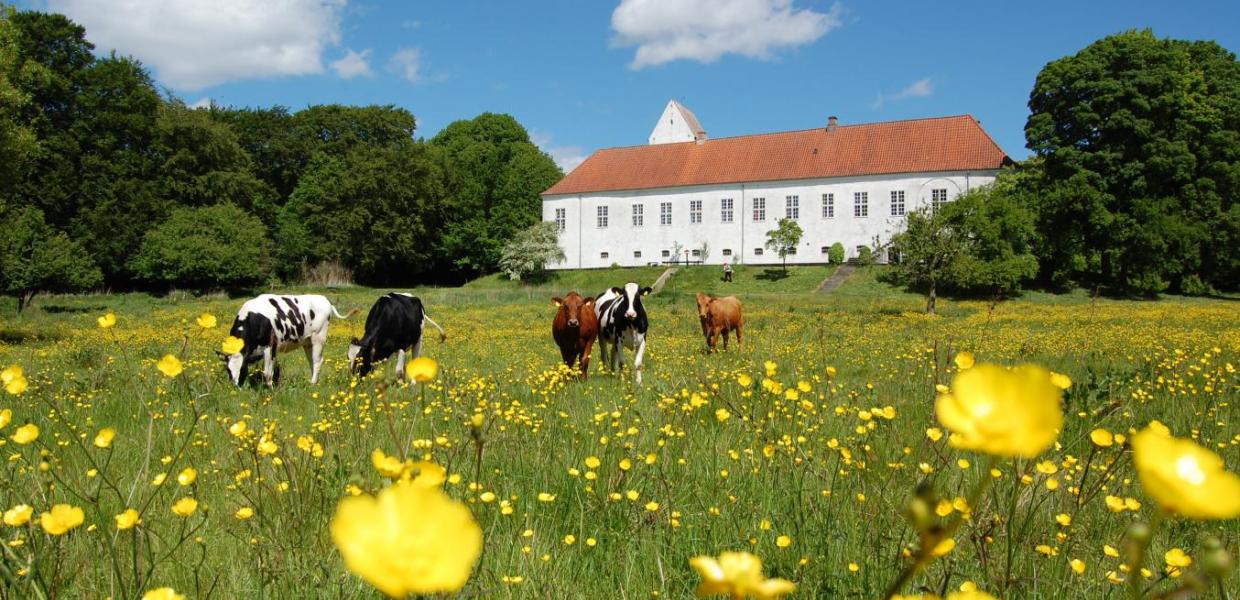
[0,207,103,312]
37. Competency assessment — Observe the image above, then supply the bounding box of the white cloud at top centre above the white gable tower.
[611,0,843,69]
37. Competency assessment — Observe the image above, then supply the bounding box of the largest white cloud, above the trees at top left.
[47,0,347,90]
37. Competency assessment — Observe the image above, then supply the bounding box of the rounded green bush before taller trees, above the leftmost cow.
[133,203,270,290]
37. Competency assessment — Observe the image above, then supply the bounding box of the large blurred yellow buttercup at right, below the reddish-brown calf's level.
[935,363,1064,457]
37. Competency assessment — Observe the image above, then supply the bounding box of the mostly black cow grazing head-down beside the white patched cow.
[348,293,448,377]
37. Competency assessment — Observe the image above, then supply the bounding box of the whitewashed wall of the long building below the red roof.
[543,170,998,269]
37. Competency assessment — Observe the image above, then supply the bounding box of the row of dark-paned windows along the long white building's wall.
[556,188,947,231]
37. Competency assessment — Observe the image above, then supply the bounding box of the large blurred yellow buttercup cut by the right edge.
[1132,429,1240,519]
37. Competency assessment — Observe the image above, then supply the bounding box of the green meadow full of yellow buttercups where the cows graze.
[0,271,1240,599]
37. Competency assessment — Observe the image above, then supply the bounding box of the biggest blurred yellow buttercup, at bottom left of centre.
[331,482,482,598]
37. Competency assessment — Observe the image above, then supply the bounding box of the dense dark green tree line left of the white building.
[0,5,562,302]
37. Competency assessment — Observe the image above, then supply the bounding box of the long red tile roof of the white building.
[543,115,1008,196]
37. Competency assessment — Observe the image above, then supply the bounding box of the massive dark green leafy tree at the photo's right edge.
[1025,31,1240,293]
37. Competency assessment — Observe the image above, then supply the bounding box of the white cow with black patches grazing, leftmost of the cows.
[221,294,356,387]
